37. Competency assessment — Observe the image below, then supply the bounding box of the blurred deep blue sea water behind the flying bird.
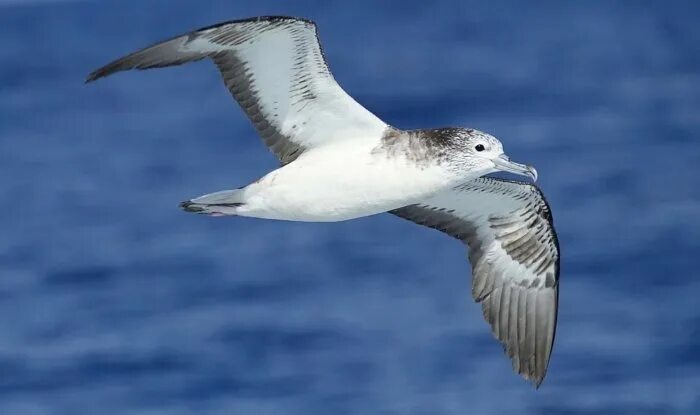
[0,0,700,415]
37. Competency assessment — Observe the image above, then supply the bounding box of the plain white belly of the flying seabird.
[239,150,450,222]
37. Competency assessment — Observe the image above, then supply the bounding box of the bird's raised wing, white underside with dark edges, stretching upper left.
[86,17,387,164]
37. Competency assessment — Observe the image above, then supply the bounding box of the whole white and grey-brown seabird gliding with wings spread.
[86,16,560,388]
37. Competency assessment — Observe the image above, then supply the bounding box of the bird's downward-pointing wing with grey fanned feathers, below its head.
[391,177,559,386]
